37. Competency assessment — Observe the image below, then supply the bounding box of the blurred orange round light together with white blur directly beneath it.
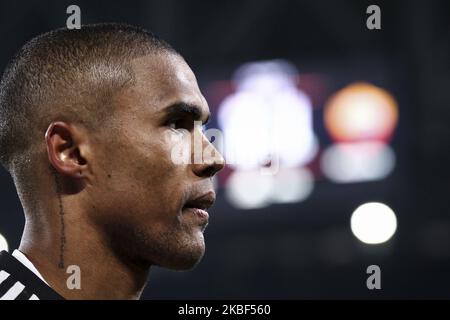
[321,83,398,183]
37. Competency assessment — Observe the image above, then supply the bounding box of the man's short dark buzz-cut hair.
[0,23,177,172]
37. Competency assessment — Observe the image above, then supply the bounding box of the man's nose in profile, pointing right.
[192,133,225,178]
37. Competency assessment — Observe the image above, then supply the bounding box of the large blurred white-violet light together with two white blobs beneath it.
[218,60,318,209]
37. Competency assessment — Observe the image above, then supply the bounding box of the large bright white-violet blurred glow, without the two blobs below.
[218,61,318,170]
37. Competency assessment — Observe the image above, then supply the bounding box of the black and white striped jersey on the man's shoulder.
[0,251,63,300]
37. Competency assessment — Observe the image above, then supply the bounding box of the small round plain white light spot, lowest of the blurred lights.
[350,202,397,244]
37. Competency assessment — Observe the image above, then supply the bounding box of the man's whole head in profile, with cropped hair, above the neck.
[0,24,223,269]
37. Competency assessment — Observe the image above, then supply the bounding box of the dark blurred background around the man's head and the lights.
[0,0,450,299]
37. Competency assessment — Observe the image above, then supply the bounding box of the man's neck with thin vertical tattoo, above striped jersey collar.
[19,202,150,299]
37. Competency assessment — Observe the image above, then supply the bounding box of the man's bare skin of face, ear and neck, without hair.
[18,53,224,299]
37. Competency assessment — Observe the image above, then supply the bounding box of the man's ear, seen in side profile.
[45,121,88,179]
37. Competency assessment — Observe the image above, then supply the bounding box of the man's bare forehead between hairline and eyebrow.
[123,53,209,113]
